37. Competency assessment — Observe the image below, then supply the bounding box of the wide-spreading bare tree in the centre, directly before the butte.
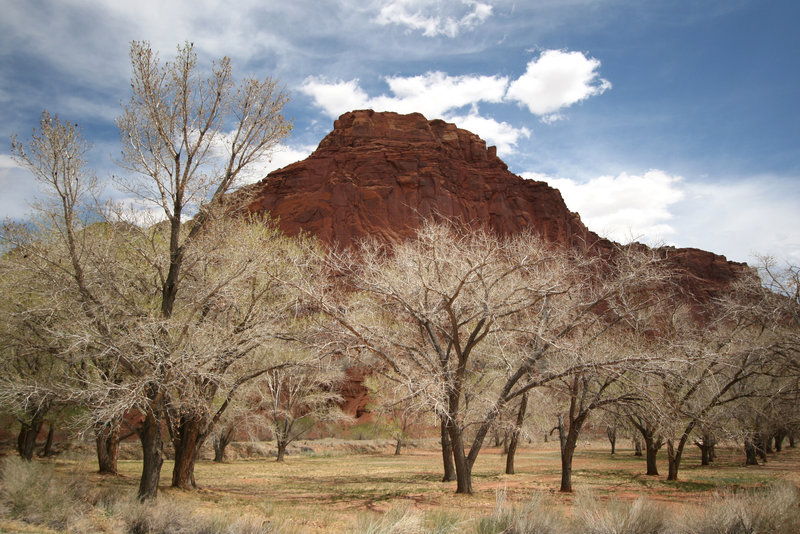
[296,224,664,493]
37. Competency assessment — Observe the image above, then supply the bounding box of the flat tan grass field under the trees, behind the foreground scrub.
[0,440,800,533]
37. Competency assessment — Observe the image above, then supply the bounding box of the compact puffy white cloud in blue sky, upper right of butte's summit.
[506,50,611,122]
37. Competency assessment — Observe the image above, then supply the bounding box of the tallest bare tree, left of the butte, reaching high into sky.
[108,42,291,499]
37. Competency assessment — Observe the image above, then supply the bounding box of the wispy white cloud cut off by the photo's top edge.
[375,0,492,38]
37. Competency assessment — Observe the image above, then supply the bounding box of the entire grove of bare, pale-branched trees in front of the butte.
[0,42,800,506]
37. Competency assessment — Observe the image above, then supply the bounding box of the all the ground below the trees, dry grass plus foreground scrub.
[0,443,800,534]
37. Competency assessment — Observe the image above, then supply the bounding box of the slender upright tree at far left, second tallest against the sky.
[1,111,125,473]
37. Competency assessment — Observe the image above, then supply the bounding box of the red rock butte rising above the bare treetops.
[237,110,748,298]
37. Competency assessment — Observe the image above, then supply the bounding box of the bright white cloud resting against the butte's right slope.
[522,170,686,243]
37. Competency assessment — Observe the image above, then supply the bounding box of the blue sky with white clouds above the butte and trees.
[0,0,800,264]
